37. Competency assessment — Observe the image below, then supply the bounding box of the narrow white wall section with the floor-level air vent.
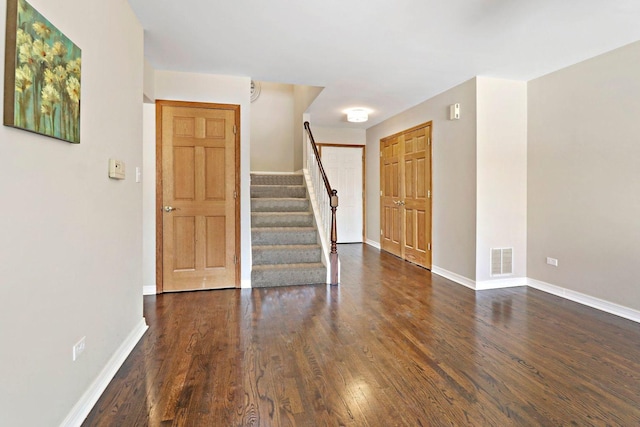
[476,77,527,287]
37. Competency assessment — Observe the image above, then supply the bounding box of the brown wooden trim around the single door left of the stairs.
[156,99,241,294]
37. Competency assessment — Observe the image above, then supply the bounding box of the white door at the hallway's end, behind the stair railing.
[321,146,364,243]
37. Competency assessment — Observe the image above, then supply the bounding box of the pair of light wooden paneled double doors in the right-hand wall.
[380,123,431,268]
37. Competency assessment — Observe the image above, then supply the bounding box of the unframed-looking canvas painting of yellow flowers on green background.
[4,0,82,144]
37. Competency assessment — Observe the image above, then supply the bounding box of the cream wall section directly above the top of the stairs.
[251,82,294,172]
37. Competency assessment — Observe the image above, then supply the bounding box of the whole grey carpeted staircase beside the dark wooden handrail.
[251,174,327,288]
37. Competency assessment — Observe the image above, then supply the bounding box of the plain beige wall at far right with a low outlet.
[527,42,640,310]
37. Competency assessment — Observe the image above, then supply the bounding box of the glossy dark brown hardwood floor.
[84,245,640,426]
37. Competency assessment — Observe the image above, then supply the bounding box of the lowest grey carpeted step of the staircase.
[251,263,327,288]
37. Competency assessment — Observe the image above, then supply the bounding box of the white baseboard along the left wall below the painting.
[60,317,149,427]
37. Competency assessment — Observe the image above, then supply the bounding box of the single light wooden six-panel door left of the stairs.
[157,101,239,292]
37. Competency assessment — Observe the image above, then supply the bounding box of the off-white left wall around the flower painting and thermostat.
[0,0,144,426]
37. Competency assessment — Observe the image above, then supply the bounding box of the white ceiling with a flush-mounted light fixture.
[129,0,640,128]
